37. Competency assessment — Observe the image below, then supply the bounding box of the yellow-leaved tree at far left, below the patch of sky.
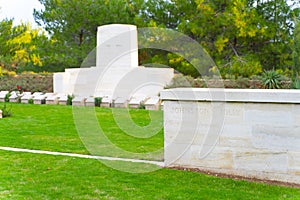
[0,19,48,70]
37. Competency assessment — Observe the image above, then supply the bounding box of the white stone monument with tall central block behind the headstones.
[54,24,174,100]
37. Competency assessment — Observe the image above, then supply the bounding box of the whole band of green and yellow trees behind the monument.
[0,0,300,78]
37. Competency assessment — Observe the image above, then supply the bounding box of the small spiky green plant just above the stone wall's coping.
[262,70,282,89]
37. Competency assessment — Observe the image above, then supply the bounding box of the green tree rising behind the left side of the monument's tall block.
[34,0,141,67]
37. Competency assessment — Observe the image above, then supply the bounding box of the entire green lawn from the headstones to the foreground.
[0,104,300,200]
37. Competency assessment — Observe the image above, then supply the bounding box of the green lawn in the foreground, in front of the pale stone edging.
[0,151,300,200]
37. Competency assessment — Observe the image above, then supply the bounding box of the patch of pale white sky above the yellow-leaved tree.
[0,0,43,27]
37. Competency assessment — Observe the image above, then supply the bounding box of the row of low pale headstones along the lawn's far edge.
[0,91,163,110]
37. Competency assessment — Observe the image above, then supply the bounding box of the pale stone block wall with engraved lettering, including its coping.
[161,88,300,184]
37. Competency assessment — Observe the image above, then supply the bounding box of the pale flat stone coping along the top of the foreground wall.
[160,88,300,104]
